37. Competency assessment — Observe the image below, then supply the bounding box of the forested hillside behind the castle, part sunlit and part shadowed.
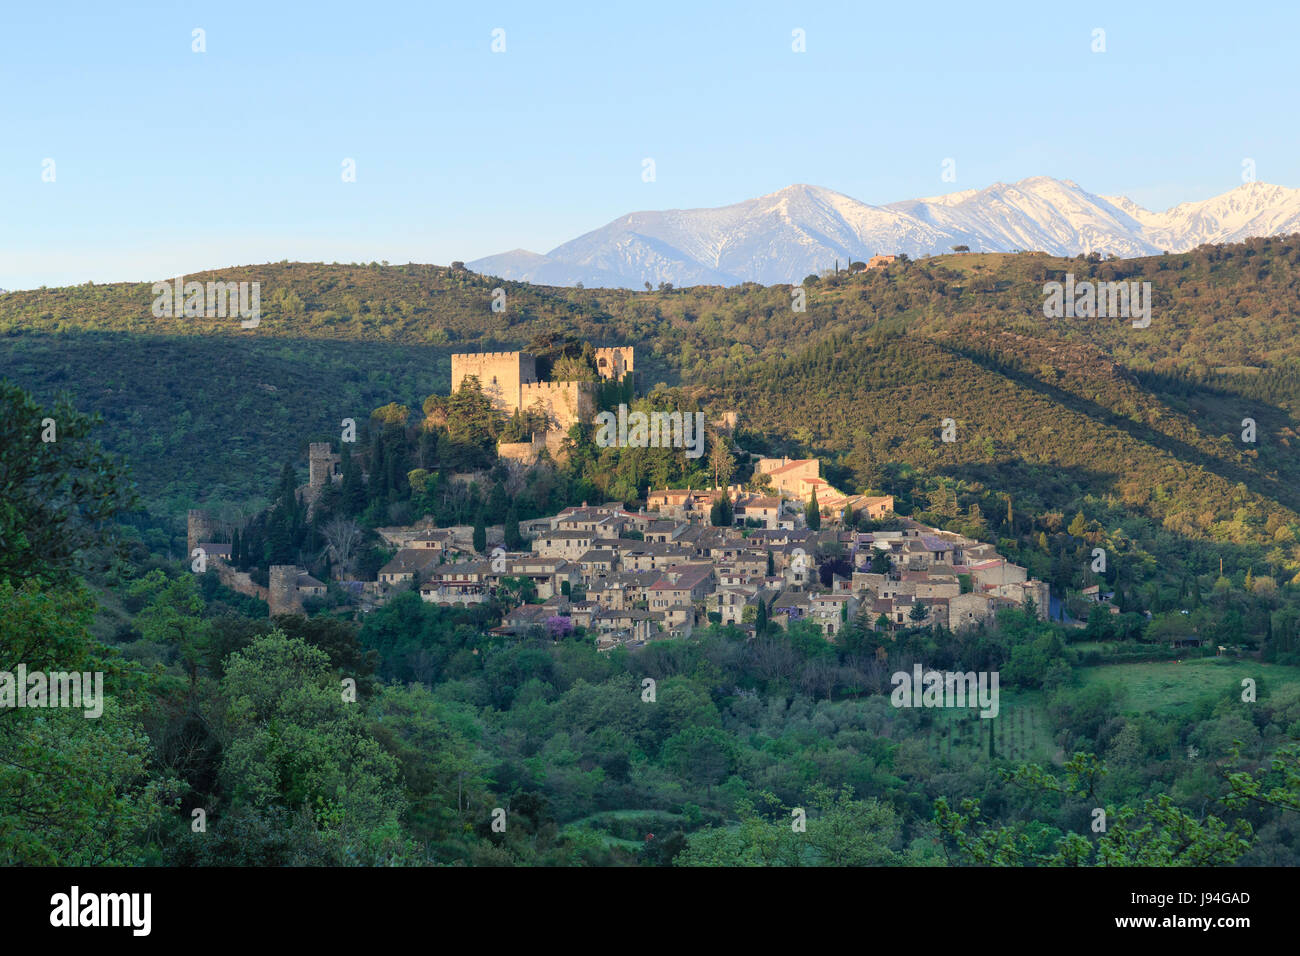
[0,237,1300,561]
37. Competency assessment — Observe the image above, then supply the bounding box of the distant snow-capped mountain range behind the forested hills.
[467,176,1300,289]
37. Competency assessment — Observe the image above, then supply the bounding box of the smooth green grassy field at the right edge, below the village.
[1079,657,1300,714]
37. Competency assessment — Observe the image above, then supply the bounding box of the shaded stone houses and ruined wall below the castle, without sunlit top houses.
[191,486,1049,649]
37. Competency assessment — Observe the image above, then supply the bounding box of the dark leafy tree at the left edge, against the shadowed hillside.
[0,380,135,583]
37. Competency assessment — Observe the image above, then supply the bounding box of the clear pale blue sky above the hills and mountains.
[0,0,1300,289]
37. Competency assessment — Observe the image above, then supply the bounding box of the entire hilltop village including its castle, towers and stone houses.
[189,349,1049,649]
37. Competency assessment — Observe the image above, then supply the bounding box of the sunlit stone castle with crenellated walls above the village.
[451,346,636,462]
